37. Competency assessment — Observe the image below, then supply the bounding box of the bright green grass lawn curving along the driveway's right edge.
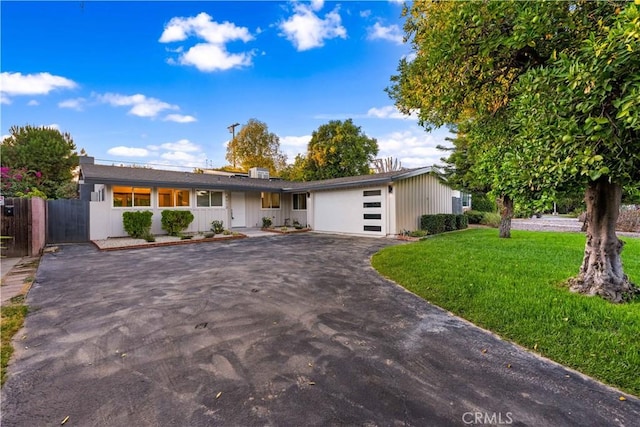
[373,229,640,396]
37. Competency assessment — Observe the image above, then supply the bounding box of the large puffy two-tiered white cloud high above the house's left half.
[159,12,254,72]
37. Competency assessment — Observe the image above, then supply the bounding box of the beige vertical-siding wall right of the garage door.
[394,174,453,233]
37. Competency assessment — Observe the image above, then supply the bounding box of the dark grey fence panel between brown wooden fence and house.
[47,199,89,244]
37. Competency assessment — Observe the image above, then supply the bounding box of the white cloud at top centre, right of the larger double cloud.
[279,1,347,52]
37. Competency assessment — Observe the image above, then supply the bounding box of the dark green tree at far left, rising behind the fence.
[0,125,78,199]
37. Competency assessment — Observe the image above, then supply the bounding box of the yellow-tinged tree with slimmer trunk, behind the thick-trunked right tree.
[387,1,616,237]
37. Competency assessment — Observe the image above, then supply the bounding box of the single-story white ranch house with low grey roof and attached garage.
[79,156,461,240]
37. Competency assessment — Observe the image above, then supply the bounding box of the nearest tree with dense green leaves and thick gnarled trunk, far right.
[511,3,640,302]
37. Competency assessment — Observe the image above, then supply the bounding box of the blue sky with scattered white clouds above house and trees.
[0,1,447,169]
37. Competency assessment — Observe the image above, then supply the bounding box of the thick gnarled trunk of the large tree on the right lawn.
[569,177,640,303]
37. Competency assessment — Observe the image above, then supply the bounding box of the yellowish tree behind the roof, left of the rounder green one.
[226,119,287,175]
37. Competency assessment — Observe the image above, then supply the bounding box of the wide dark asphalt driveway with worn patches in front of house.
[1,233,640,427]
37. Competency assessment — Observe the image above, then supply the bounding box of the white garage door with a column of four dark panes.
[313,188,386,236]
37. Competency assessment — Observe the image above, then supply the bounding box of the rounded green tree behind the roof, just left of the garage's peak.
[303,119,378,181]
